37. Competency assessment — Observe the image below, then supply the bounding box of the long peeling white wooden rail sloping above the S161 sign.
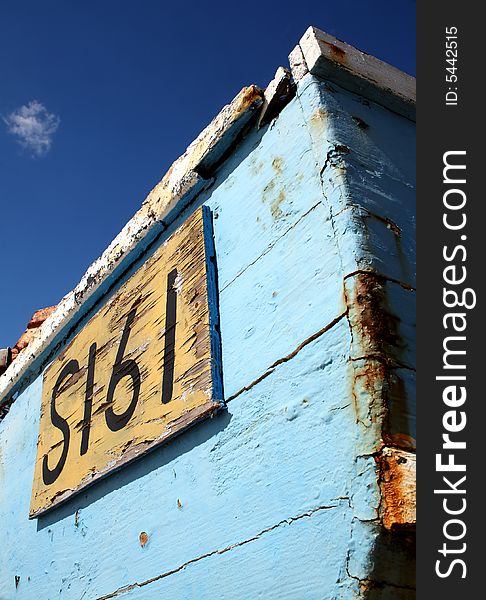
[0,85,263,412]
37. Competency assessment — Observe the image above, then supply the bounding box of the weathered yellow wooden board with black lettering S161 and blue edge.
[30,208,222,518]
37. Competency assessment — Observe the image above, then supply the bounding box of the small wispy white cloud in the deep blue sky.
[3,100,60,156]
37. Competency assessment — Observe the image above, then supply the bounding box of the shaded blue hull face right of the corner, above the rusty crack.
[300,75,415,286]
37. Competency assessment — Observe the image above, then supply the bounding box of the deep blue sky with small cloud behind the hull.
[0,0,415,347]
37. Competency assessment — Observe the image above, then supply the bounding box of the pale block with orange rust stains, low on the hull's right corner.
[375,448,416,529]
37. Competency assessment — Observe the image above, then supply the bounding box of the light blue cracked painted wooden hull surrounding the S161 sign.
[0,69,414,600]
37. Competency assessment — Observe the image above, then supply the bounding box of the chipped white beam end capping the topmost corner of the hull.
[290,27,415,120]
